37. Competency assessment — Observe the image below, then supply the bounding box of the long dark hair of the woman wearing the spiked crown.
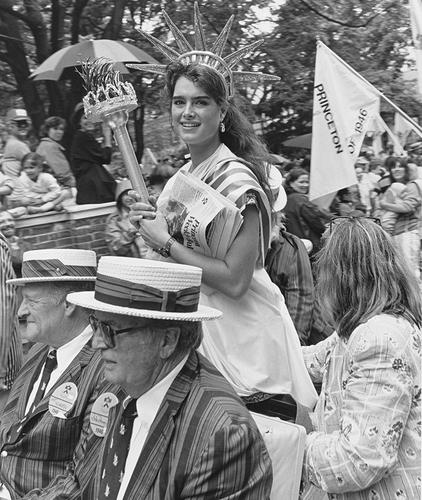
[165,62,273,204]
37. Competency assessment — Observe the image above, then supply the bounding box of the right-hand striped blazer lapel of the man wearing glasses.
[124,352,198,499]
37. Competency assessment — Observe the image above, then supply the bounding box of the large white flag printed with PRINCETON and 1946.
[309,42,380,206]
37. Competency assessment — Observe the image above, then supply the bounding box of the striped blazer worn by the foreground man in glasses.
[82,352,272,500]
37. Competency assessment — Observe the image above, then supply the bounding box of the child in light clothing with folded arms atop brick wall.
[8,153,69,214]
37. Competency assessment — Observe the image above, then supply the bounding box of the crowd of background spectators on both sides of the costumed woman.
[0,105,422,352]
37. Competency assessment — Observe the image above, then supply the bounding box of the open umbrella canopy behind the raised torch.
[30,40,158,81]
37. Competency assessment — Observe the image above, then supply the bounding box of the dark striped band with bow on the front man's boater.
[94,274,200,312]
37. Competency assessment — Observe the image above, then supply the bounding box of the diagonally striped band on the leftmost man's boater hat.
[22,259,96,278]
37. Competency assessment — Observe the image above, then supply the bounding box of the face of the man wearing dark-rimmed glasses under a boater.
[92,311,165,397]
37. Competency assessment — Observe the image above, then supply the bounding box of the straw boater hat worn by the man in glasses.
[67,257,221,321]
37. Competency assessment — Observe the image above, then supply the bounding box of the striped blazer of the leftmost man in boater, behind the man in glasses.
[0,345,102,498]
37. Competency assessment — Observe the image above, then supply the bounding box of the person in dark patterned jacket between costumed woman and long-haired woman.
[265,212,314,345]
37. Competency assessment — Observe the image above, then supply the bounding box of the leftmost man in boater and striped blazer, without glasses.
[0,249,122,498]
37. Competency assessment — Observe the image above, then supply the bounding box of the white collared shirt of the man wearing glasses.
[116,355,189,500]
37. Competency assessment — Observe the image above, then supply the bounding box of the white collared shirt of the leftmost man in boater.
[25,326,92,414]
